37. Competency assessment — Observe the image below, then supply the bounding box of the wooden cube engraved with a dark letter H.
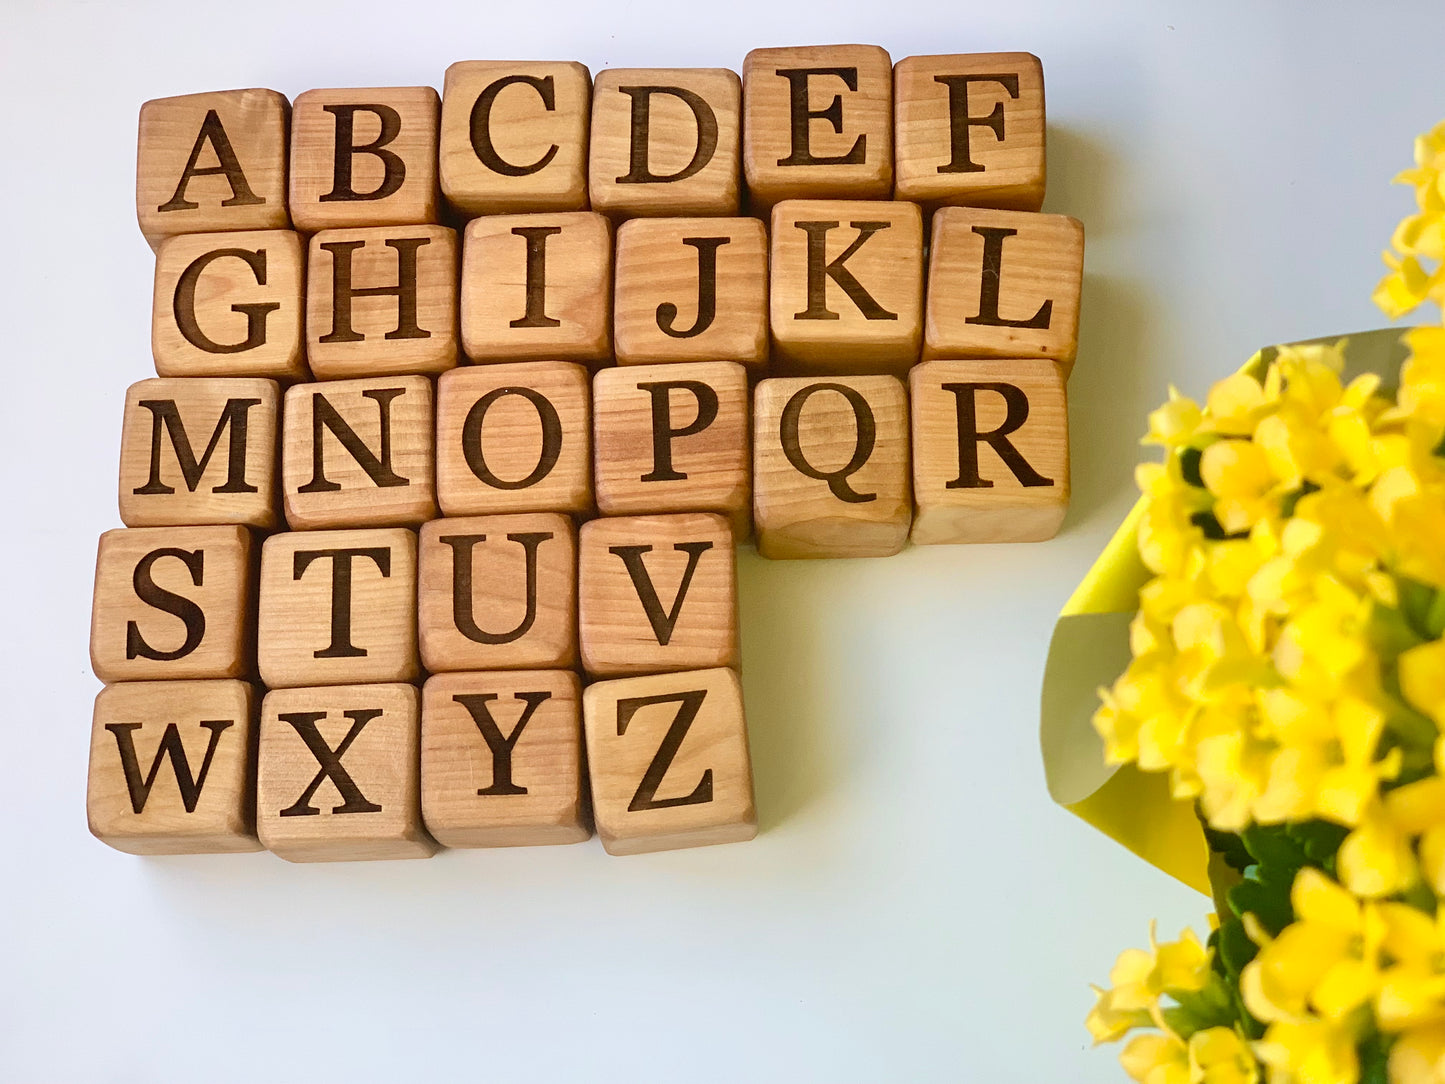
[306,225,458,380]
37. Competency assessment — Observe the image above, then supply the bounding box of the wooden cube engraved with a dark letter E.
[743,45,893,210]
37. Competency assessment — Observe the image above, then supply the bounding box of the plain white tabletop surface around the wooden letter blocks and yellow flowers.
[0,0,1445,1084]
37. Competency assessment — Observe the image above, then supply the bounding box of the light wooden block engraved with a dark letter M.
[120,377,280,529]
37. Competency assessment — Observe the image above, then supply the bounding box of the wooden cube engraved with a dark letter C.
[441,61,592,217]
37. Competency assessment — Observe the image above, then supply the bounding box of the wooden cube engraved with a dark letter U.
[418,512,577,671]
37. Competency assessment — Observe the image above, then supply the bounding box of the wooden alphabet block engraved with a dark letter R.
[909,358,1069,545]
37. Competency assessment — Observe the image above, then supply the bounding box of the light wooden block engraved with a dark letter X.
[256,685,436,861]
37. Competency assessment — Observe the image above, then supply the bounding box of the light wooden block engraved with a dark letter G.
[150,230,308,380]
